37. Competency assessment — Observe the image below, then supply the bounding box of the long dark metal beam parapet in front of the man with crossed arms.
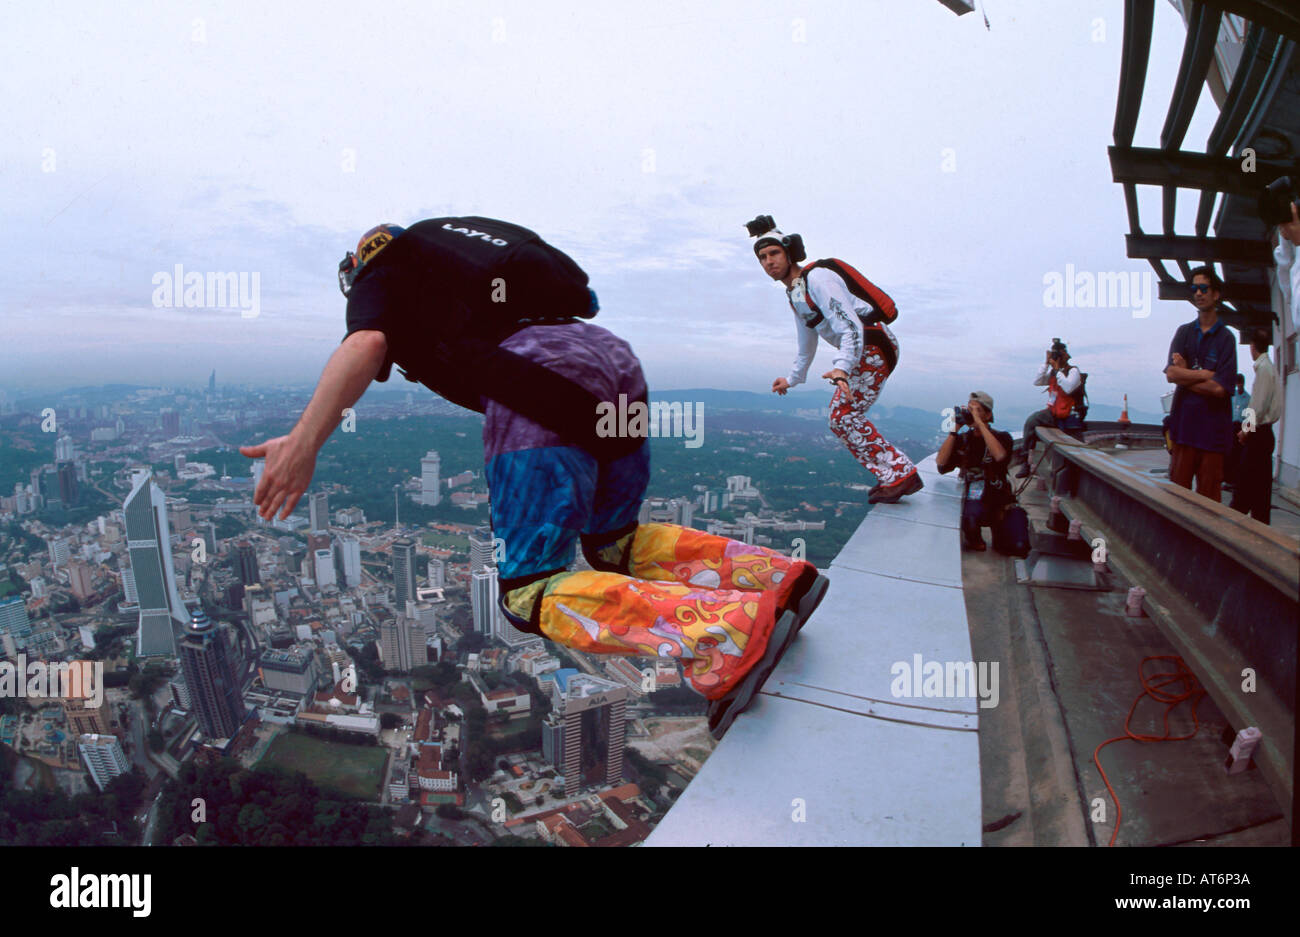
[1041,429,1300,817]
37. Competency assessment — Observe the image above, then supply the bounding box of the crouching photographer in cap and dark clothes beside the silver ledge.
[935,390,1030,556]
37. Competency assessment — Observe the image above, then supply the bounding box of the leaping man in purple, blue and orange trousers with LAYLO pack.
[239,217,827,738]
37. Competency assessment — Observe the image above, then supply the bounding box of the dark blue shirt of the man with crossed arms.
[1165,318,1236,452]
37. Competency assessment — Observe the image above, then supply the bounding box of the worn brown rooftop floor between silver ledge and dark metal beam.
[962,448,1290,846]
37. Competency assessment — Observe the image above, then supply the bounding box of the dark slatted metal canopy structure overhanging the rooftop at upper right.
[1109,0,1300,342]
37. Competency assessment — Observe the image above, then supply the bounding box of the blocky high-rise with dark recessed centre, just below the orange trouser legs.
[542,669,628,797]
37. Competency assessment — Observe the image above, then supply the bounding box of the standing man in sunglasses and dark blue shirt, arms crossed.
[1165,266,1236,502]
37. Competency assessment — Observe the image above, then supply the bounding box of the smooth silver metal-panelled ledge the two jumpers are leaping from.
[645,456,983,846]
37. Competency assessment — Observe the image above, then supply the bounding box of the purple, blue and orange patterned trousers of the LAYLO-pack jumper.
[484,322,809,699]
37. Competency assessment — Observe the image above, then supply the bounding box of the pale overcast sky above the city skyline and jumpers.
[0,0,1249,411]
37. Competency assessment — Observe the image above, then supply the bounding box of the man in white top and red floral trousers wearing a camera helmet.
[745,214,923,504]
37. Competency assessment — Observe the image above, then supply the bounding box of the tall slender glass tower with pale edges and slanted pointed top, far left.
[122,469,190,658]
